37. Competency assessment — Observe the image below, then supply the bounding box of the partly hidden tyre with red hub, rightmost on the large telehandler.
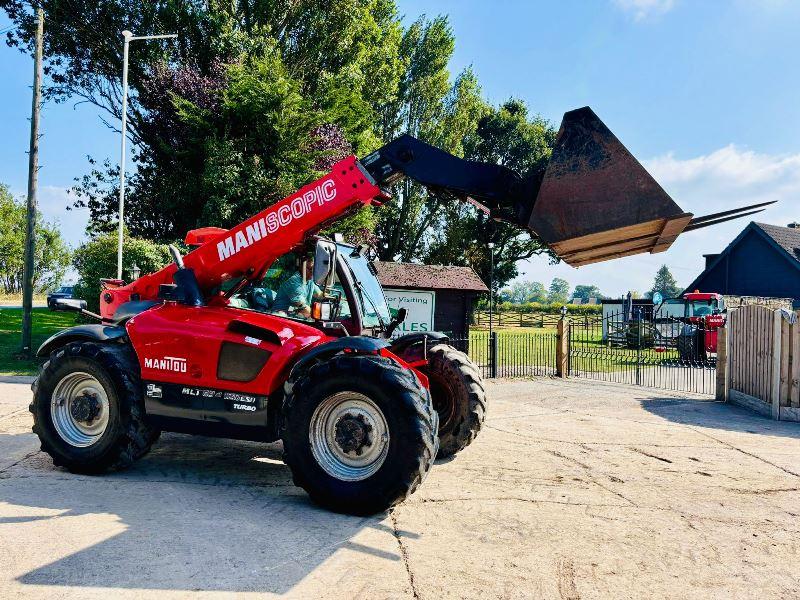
[422,344,486,458]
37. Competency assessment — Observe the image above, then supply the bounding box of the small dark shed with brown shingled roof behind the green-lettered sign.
[375,262,489,337]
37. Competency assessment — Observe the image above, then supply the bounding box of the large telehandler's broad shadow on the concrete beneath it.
[0,434,417,593]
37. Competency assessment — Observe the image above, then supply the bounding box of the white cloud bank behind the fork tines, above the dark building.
[519,145,800,295]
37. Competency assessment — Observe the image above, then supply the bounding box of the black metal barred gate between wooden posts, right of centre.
[568,311,716,394]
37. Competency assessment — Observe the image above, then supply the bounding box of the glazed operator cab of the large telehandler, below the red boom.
[222,238,398,337]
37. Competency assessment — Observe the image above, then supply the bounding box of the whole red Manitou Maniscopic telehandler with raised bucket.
[31,108,768,514]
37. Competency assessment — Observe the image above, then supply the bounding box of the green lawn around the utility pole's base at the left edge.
[0,308,75,375]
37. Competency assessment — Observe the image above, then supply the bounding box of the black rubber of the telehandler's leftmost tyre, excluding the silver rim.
[30,342,160,474]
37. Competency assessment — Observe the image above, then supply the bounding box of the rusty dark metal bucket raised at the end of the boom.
[528,107,692,267]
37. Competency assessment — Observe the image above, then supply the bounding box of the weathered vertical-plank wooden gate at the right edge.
[719,305,800,421]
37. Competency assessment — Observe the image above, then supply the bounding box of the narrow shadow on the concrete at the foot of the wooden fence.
[638,398,800,439]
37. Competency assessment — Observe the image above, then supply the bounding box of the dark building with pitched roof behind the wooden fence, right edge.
[686,222,800,308]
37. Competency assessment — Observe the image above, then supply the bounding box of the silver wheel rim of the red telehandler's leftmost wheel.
[50,372,109,448]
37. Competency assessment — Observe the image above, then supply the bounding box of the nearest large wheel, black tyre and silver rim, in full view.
[281,355,438,515]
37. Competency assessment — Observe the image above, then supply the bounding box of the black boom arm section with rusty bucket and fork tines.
[360,106,771,267]
